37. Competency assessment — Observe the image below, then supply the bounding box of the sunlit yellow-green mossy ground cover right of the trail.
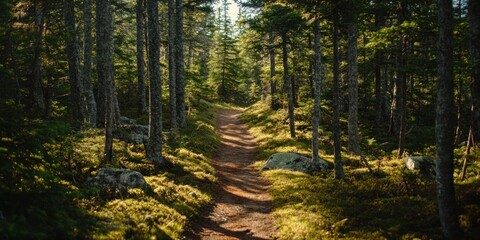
[242,102,480,239]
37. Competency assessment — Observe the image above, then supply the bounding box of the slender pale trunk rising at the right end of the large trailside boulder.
[312,18,323,162]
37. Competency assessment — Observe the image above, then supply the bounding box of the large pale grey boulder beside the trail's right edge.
[260,153,328,174]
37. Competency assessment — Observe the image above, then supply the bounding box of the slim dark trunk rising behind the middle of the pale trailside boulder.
[282,33,295,138]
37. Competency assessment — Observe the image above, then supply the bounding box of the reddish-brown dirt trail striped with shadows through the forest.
[186,109,275,240]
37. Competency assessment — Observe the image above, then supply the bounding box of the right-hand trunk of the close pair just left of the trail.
[175,0,187,127]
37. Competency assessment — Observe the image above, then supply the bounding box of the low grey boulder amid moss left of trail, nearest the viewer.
[87,168,148,193]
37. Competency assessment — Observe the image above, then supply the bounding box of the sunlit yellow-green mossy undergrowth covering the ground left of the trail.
[0,98,220,239]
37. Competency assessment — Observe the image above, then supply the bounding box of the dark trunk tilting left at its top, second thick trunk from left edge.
[64,0,86,130]
